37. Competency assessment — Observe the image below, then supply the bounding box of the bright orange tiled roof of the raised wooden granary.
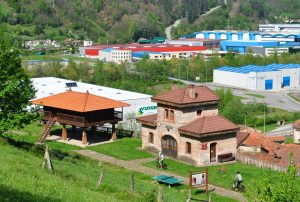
[32,91,129,112]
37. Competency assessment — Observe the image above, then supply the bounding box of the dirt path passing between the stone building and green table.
[76,150,247,202]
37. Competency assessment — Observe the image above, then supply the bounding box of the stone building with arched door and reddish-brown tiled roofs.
[138,85,239,166]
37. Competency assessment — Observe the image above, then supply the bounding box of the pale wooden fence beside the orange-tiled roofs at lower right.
[236,152,300,176]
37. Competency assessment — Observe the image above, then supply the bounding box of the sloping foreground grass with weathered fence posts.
[0,128,235,202]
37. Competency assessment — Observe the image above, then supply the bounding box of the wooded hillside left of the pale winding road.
[0,0,219,43]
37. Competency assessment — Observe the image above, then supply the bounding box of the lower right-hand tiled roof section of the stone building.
[178,115,239,135]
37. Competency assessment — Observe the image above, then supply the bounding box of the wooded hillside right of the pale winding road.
[172,0,300,37]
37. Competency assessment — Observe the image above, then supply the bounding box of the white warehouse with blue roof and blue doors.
[213,64,300,91]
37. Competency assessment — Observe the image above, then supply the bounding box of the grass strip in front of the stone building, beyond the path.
[145,159,300,189]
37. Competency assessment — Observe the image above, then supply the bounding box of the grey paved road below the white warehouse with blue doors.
[169,77,300,112]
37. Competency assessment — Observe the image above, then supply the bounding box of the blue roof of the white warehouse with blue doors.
[216,64,300,74]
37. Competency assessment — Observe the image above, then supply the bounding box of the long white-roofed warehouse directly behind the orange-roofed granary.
[31,77,157,118]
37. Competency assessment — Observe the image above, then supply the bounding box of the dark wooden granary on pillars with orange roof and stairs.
[32,91,129,145]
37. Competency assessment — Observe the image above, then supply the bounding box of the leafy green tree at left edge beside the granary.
[0,40,35,133]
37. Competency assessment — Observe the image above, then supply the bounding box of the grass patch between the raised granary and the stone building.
[88,138,153,160]
